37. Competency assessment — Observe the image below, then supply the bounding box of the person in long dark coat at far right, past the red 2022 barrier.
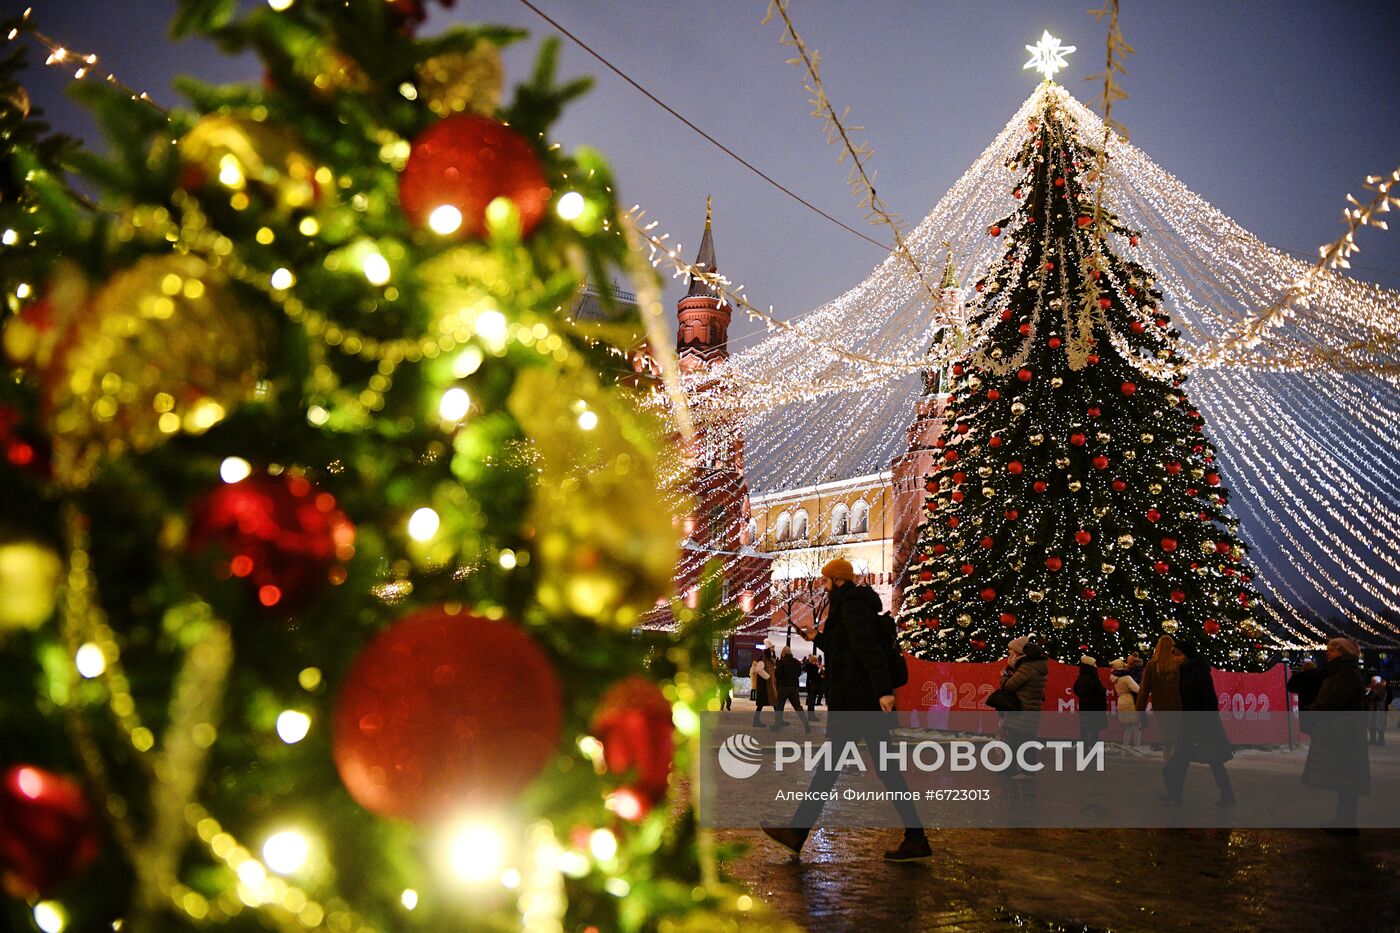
[1303,639,1371,834]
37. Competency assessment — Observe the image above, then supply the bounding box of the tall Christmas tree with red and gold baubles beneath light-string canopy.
[900,83,1268,670]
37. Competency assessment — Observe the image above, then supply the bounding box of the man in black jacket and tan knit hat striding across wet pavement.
[763,558,932,862]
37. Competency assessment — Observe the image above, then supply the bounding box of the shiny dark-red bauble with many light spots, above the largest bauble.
[188,474,354,611]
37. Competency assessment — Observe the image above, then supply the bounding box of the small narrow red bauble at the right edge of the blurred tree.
[591,675,676,820]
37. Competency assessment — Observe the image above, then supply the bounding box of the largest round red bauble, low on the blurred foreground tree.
[333,607,563,822]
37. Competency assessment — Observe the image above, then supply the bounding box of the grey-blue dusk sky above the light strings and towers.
[19,0,1400,345]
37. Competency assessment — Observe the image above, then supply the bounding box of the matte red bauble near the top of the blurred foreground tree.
[399,113,550,237]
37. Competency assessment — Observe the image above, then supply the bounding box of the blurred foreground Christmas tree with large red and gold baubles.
[0,0,789,930]
